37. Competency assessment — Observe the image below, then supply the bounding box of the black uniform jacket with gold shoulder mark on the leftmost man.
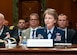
[0,26,19,43]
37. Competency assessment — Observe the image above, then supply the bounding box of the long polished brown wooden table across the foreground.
[0,44,77,55]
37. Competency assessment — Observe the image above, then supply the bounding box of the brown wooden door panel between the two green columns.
[19,0,41,19]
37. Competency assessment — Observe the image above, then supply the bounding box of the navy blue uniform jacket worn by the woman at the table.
[36,27,65,43]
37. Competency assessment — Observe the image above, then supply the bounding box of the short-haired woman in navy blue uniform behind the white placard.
[36,8,65,43]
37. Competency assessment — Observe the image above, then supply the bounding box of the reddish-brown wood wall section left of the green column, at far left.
[0,0,13,25]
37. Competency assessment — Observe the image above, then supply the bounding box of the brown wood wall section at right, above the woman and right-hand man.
[46,0,77,27]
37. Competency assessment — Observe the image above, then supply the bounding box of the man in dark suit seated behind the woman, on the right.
[57,14,76,43]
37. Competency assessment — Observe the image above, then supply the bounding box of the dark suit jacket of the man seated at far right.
[67,28,76,44]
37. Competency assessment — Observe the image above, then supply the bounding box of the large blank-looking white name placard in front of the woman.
[27,39,53,47]
